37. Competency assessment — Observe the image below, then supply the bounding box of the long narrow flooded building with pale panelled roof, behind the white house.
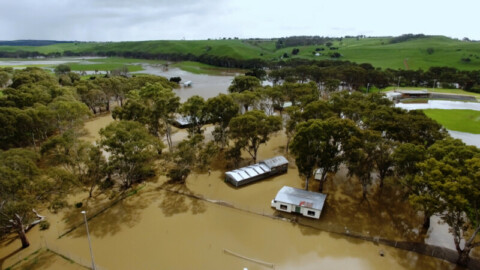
[225,156,288,187]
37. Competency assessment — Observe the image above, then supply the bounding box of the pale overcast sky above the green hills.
[0,0,480,41]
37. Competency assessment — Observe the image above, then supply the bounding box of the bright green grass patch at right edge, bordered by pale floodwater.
[423,109,480,134]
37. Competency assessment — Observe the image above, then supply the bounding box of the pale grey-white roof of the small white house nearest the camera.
[275,186,327,211]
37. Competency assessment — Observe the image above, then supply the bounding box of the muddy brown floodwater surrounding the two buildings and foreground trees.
[0,89,466,270]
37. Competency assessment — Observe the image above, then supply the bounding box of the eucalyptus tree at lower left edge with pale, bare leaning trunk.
[0,149,71,248]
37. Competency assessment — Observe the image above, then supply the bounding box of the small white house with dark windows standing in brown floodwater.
[272,186,327,219]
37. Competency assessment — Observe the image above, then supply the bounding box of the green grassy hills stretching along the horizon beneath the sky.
[0,36,480,70]
